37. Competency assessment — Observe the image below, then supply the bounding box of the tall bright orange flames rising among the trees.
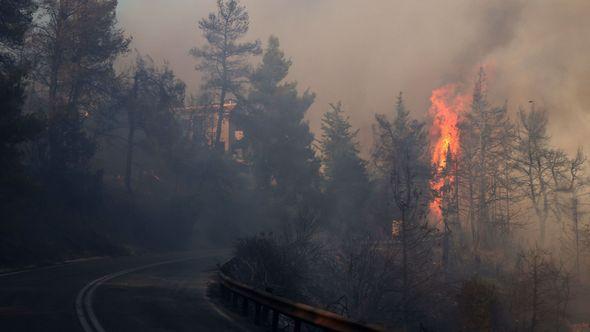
[428,84,469,222]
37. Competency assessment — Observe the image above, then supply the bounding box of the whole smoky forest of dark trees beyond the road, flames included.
[0,0,590,331]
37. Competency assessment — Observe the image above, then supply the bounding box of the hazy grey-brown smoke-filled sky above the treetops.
[119,0,590,154]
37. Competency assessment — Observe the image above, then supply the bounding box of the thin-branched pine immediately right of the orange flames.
[458,69,514,248]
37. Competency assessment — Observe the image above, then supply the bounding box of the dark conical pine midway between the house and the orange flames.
[320,103,369,235]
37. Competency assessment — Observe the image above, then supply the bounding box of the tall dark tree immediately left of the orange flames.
[373,94,437,327]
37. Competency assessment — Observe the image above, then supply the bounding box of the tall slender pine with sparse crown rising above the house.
[191,0,261,147]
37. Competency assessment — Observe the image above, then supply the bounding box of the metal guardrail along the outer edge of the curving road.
[219,272,385,332]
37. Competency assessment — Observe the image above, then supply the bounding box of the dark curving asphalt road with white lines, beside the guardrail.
[0,249,243,332]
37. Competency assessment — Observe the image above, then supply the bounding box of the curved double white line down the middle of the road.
[76,257,200,332]
